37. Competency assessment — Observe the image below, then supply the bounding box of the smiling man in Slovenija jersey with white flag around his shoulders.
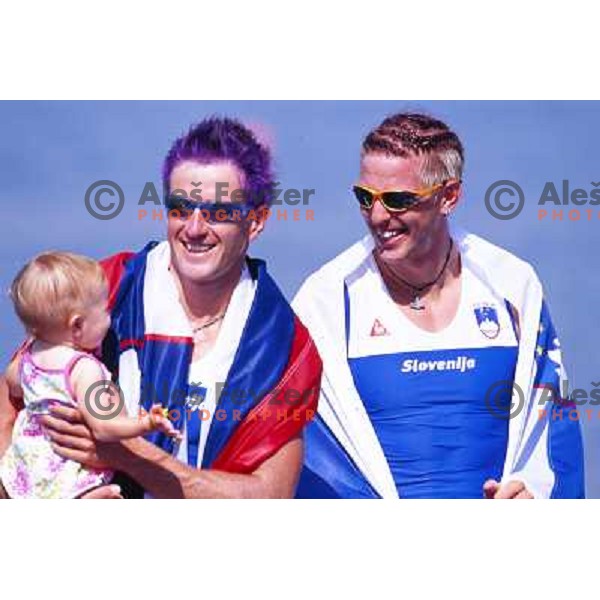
[294,113,584,499]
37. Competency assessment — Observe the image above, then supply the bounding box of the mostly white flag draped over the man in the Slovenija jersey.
[293,231,584,498]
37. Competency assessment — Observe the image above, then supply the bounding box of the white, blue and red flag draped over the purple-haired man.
[102,242,322,473]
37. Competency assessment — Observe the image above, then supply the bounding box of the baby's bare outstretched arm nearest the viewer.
[71,358,180,442]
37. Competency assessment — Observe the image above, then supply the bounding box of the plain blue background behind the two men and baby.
[0,101,600,498]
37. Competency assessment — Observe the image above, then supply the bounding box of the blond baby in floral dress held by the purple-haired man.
[0,252,181,498]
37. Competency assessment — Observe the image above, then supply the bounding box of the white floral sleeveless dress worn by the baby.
[0,344,113,499]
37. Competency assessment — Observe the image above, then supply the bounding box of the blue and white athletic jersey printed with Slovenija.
[346,258,518,498]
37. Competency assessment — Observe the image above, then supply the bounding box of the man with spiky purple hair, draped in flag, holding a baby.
[0,118,321,498]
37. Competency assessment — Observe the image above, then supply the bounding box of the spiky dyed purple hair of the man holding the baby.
[162,117,275,206]
